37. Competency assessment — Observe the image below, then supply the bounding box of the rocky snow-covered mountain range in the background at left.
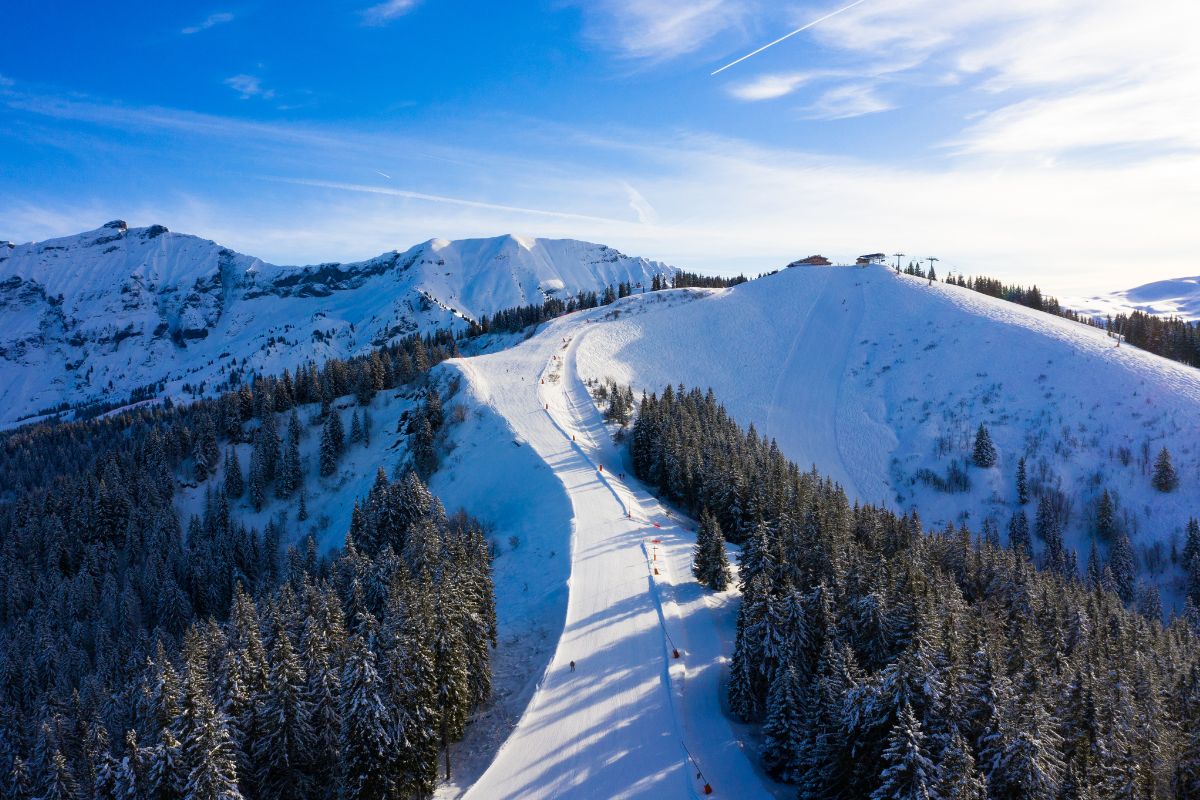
[0,221,673,425]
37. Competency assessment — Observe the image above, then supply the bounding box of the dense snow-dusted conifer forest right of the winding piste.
[630,387,1200,800]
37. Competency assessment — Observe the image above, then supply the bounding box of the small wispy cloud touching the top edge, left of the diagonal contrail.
[580,0,750,61]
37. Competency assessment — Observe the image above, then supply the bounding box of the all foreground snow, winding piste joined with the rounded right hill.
[434,261,1200,800]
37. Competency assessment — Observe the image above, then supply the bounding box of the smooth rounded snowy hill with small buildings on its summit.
[568,267,1200,603]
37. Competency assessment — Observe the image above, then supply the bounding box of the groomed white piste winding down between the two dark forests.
[451,302,769,799]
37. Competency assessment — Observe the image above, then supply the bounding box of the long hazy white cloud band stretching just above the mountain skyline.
[9,90,1200,295]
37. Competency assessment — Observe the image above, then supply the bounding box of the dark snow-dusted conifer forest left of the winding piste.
[0,323,494,800]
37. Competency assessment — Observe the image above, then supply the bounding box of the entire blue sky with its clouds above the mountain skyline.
[0,0,1200,293]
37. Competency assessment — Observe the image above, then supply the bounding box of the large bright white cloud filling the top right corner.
[812,0,1200,161]
